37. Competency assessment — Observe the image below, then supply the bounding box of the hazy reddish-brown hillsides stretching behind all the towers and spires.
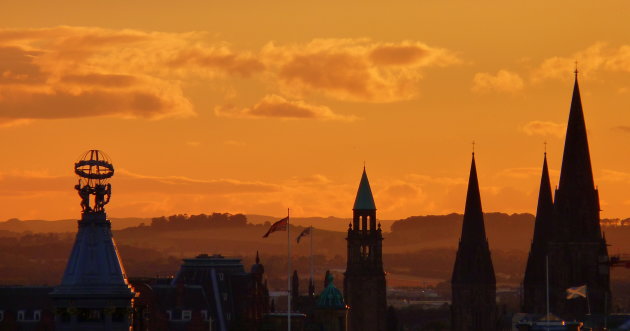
[0,213,630,288]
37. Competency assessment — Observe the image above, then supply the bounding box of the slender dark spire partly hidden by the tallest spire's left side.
[523,153,553,314]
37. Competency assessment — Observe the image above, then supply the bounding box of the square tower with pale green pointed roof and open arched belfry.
[344,168,387,331]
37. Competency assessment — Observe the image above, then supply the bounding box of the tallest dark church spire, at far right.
[549,70,611,319]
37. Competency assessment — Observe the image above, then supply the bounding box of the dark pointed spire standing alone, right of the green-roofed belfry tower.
[451,153,497,331]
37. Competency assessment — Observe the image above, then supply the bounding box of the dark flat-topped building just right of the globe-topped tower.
[132,253,269,331]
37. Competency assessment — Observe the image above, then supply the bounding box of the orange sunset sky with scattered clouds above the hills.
[0,0,630,220]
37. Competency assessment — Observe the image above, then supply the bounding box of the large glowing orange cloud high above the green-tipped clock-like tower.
[262,39,460,102]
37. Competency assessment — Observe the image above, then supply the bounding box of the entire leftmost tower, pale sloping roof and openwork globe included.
[51,150,134,331]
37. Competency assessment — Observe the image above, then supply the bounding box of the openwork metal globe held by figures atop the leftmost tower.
[74,149,114,213]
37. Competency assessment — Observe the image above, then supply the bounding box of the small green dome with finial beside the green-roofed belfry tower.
[315,274,348,331]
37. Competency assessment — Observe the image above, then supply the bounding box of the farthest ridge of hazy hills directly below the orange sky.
[0,212,630,254]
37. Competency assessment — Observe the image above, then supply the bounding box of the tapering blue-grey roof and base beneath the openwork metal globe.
[51,211,134,331]
